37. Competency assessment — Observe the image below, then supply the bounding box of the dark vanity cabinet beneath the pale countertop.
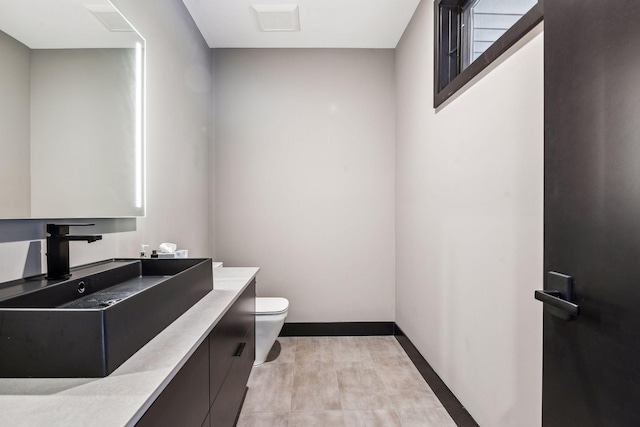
[137,280,256,427]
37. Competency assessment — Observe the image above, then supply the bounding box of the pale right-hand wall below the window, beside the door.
[396,0,543,427]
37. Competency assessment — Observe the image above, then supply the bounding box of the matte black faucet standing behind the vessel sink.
[46,224,102,279]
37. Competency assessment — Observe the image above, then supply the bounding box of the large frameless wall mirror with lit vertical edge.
[0,0,145,219]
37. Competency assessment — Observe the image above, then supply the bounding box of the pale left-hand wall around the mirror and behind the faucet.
[0,0,211,281]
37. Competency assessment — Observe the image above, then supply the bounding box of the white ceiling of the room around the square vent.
[182,0,420,49]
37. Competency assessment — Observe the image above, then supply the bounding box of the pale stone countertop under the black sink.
[0,267,259,427]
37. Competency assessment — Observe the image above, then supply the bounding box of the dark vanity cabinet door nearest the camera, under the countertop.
[136,340,209,427]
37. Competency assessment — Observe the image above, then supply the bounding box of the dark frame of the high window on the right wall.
[433,0,544,108]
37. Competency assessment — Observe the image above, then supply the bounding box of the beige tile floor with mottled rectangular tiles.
[237,336,456,427]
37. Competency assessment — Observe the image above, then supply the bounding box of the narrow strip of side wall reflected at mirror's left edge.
[0,31,31,217]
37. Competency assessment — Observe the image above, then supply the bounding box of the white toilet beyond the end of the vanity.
[253,297,289,366]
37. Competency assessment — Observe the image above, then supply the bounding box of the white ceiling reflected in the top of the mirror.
[0,0,142,49]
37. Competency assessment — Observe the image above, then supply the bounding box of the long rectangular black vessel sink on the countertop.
[0,258,213,377]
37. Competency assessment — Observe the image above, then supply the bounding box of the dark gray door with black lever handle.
[543,0,640,427]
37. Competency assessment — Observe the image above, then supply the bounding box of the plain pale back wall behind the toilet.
[214,49,395,322]
